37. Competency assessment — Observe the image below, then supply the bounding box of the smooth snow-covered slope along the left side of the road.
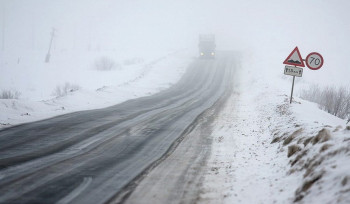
[0,50,191,128]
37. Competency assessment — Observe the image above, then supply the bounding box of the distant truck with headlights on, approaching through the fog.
[198,35,216,59]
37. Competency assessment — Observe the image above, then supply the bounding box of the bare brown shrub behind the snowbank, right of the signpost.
[300,85,350,119]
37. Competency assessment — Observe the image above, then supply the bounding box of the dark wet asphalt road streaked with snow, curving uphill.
[0,53,235,204]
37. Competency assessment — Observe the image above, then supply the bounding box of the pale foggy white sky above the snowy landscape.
[0,0,350,84]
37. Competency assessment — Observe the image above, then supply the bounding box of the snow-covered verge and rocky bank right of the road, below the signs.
[200,51,350,203]
